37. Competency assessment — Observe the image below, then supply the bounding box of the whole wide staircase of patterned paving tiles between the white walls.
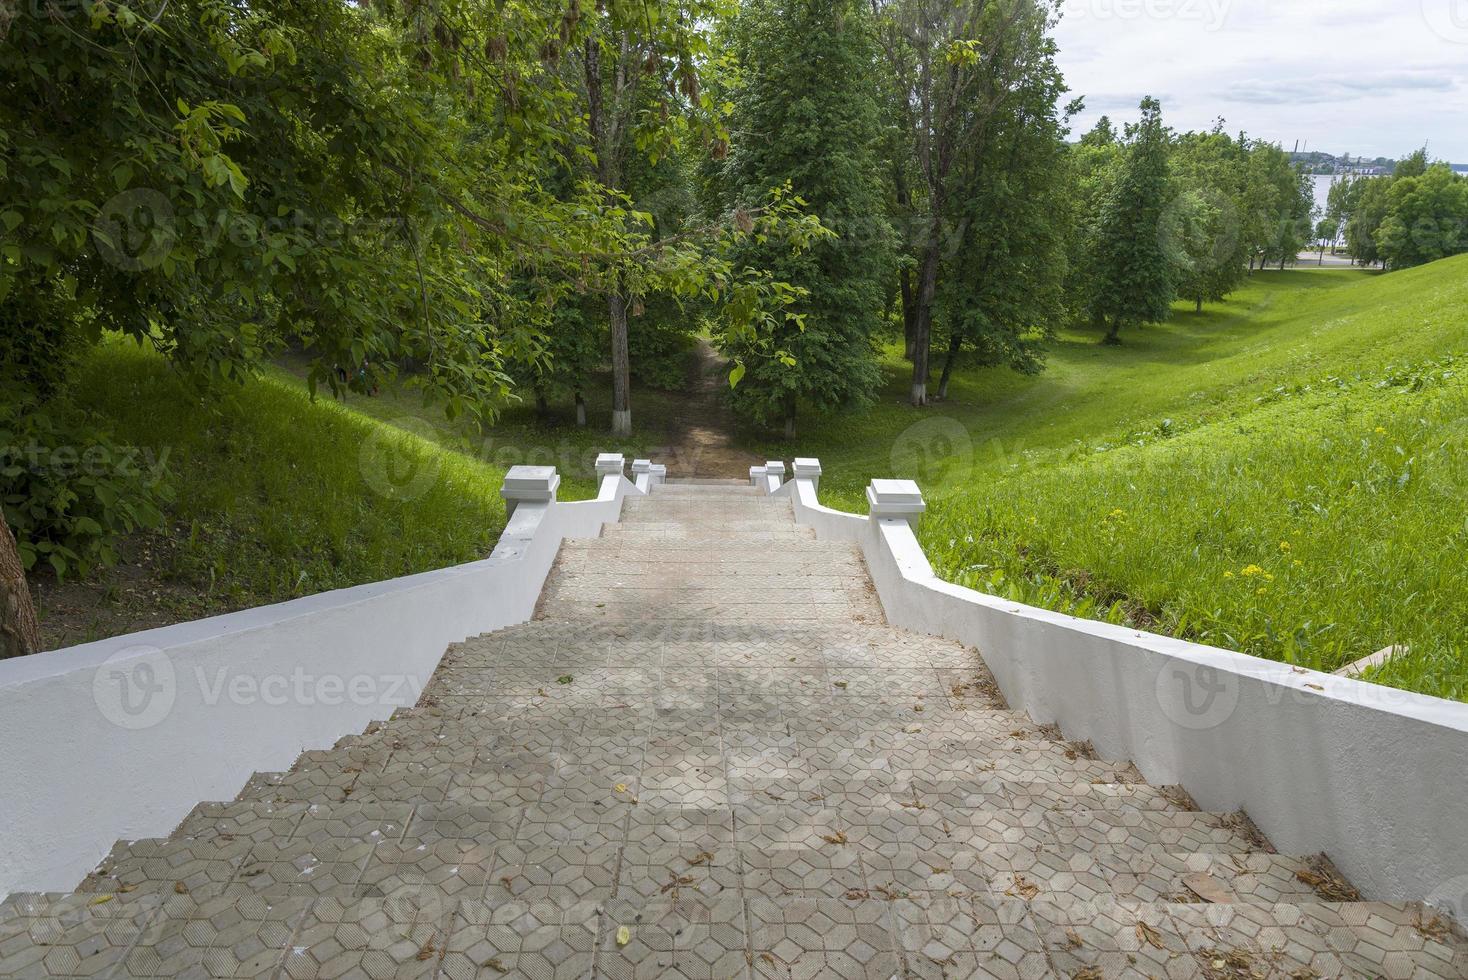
[0,481,1468,980]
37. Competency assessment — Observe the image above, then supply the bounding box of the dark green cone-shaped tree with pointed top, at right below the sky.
[1092,97,1176,343]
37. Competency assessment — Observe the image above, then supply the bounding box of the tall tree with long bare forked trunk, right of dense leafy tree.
[875,0,1054,406]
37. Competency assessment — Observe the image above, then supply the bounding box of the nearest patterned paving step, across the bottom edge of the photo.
[0,891,1468,979]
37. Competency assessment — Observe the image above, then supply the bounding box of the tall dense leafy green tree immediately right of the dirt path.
[724,0,894,437]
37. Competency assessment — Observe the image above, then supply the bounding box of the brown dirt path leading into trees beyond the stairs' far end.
[658,337,763,480]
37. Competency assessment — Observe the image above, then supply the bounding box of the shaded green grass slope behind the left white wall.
[76,342,505,612]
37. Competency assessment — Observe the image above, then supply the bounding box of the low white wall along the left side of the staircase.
[0,475,639,896]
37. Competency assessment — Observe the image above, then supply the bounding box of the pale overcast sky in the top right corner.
[1057,0,1468,164]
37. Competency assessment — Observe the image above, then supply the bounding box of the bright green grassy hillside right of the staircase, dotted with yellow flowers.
[745,257,1468,698]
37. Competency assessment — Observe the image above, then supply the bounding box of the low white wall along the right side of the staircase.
[756,461,1468,921]
